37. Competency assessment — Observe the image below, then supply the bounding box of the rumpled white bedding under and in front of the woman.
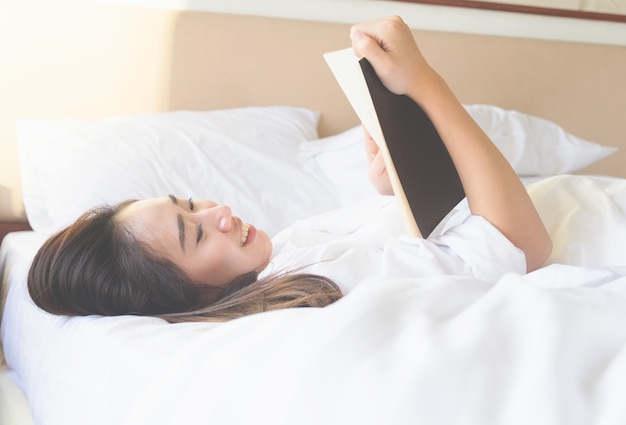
[0,174,626,425]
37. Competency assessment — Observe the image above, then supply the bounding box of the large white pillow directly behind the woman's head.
[17,106,337,235]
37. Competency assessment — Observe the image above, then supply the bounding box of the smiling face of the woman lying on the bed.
[117,195,272,287]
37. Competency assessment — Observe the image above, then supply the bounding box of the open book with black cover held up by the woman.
[324,48,465,238]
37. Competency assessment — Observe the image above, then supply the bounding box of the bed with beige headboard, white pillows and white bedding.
[0,5,626,425]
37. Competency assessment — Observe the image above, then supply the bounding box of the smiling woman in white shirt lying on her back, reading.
[28,17,551,321]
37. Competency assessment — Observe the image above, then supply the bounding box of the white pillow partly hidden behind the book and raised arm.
[299,105,617,203]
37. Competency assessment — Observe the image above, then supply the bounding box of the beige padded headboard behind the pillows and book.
[169,12,626,177]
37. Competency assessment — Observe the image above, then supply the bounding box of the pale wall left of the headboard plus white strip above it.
[0,0,626,220]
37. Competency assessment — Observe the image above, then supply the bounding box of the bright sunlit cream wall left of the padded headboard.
[0,0,175,220]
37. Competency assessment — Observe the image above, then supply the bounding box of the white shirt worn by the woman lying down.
[261,196,526,293]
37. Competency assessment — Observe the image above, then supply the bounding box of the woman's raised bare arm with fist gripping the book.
[351,16,552,271]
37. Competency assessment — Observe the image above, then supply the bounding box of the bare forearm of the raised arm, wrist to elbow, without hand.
[407,71,552,271]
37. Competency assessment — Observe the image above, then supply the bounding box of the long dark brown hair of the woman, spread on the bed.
[28,201,341,322]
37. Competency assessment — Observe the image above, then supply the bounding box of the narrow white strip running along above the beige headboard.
[91,0,626,46]
